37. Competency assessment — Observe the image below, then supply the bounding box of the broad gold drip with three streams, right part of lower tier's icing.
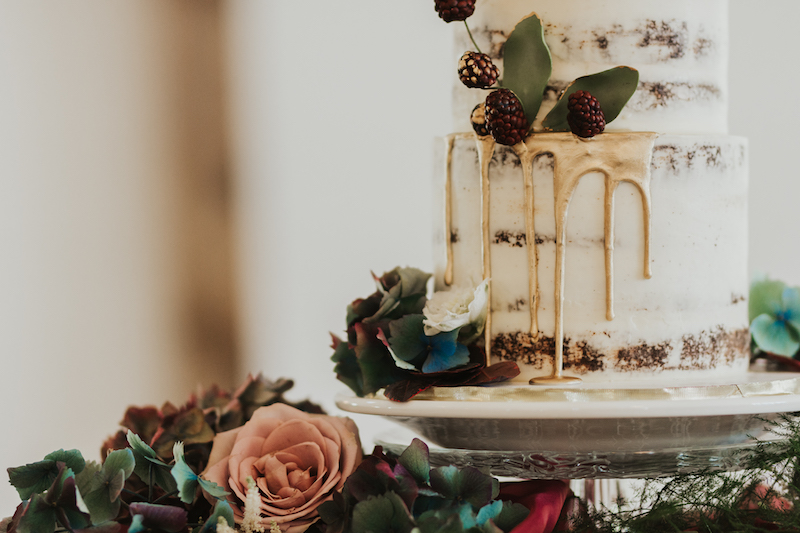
[526,133,656,383]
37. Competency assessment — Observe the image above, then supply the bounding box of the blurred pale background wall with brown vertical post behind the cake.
[0,0,800,517]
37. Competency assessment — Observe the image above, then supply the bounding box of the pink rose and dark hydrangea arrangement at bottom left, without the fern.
[0,376,569,533]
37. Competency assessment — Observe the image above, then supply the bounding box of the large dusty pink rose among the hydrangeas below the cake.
[203,403,362,533]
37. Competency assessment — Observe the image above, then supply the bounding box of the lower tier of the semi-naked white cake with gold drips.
[434,133,749,381]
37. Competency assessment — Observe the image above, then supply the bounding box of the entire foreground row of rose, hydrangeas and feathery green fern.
[0,376,800,533]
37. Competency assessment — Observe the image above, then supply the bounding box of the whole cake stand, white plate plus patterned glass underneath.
[336,372,800,479]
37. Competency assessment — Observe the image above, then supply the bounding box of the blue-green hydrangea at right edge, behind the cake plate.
[750,280,800,357]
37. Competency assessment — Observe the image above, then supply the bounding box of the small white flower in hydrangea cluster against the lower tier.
[422,279,489,337]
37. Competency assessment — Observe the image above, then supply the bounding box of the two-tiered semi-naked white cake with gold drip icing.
[435,0,749,383]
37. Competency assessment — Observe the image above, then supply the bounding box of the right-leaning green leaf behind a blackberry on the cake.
[542,67,639,131]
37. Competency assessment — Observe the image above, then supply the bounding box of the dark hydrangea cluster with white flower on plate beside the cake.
[331,267,519,401]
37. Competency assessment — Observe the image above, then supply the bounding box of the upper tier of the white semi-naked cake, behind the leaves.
[453,0,728,133]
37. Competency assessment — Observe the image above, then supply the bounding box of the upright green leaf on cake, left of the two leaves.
[503,13,553,124]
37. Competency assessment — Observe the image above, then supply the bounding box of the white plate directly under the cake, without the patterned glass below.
[336,372,800,458]
